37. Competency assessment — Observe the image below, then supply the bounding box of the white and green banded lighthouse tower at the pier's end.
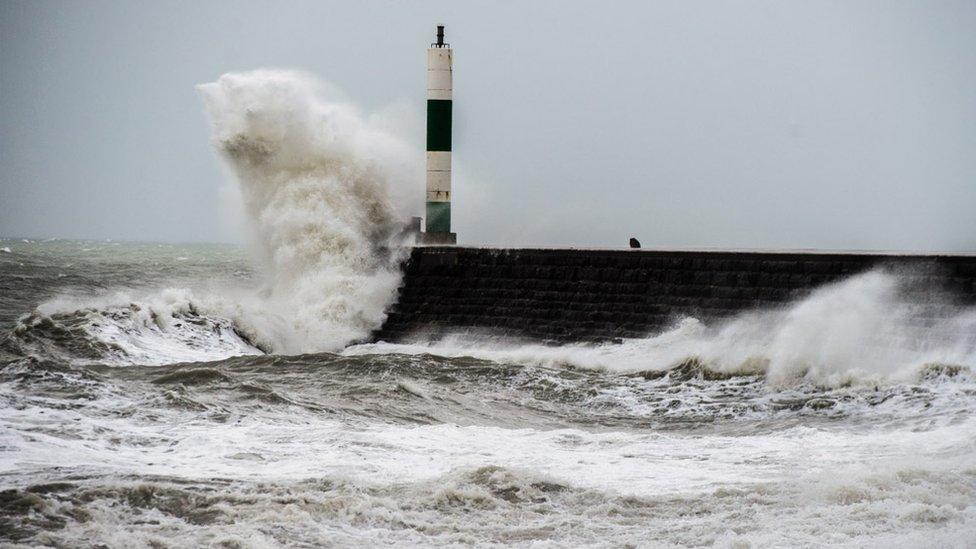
[423,25,457,244]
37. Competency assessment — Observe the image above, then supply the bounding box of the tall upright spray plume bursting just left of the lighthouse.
[198,70,413,353]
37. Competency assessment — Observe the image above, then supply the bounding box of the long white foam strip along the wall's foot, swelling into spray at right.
[354,272,976,387]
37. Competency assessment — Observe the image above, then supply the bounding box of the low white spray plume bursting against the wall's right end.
[686,270,976,387]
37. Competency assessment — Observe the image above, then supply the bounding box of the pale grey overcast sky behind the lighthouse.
[0,0,976,251]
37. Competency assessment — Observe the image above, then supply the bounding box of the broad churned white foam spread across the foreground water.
[0,378,976,546]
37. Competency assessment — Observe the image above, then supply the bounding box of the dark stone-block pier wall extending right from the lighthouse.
[373,247,976,342]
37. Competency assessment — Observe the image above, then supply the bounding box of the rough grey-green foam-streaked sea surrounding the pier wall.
[0,240,976,547]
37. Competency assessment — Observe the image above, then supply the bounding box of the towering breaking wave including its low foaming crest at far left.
[4,71,418,364]
